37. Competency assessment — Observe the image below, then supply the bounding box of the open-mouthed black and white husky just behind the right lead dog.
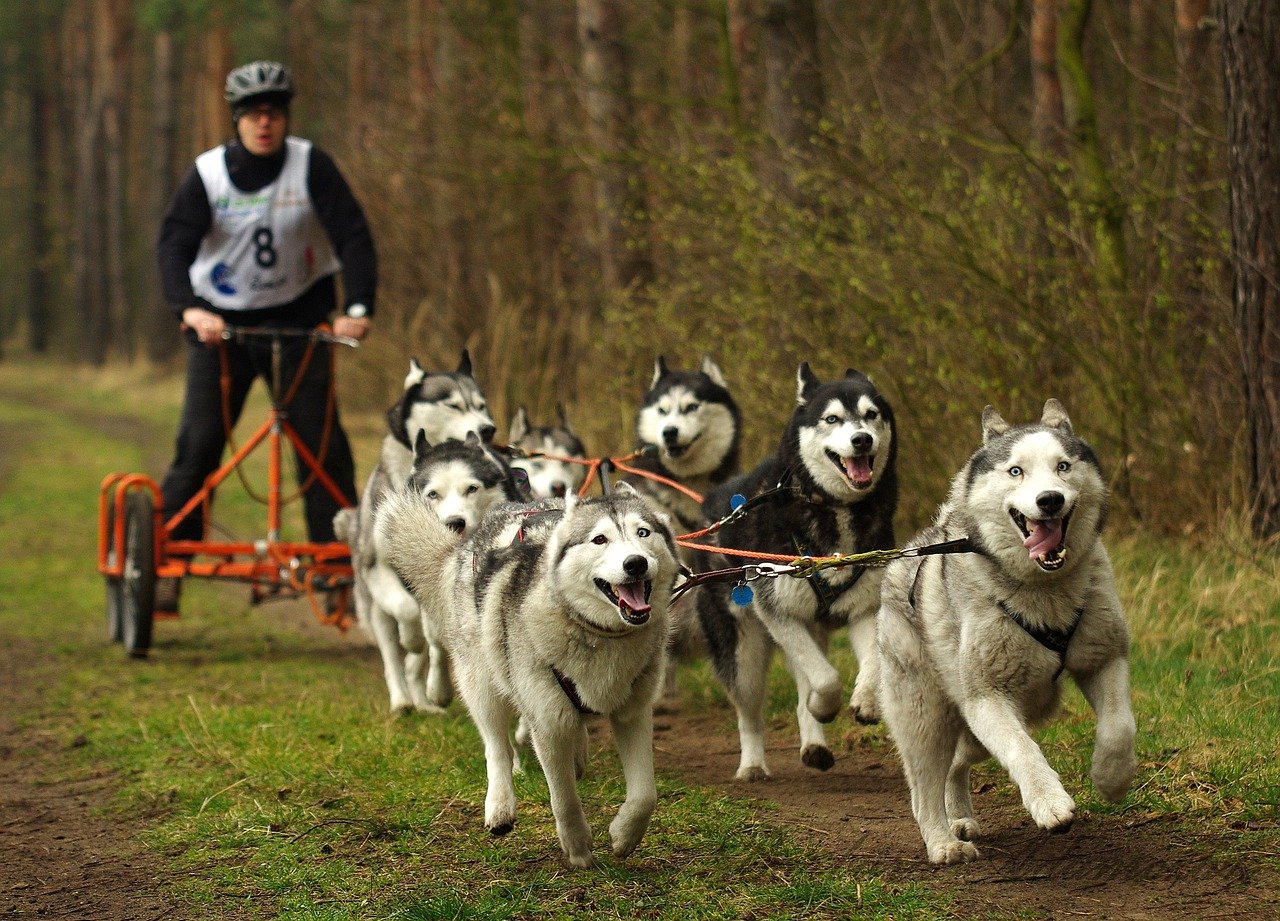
[698,362,897,780]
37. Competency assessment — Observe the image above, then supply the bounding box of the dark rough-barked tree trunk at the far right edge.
[1217,0,1280,540]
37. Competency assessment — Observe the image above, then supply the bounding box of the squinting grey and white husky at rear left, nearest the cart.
[334,349,497,710]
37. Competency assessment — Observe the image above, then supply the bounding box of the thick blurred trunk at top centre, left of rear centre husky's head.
[577,0,653,288]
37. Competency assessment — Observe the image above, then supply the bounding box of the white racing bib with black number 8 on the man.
[189,137,342,311]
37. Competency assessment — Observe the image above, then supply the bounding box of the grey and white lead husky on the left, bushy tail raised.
[378,485,677,867]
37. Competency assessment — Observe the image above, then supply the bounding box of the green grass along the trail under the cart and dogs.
[0,355,1280,918]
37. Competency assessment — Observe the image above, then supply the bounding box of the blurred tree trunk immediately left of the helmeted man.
[138,29,182,362]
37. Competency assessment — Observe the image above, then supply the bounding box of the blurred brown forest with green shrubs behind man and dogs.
[0,0,1266,537]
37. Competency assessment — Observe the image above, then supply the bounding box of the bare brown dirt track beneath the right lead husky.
[655,712,1280,918]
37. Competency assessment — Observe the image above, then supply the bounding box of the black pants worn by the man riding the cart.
[160,333,356,541]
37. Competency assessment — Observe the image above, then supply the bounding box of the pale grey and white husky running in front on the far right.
[879,399,1135,863]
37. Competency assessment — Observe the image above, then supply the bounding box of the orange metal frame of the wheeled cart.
[97,335,353,631]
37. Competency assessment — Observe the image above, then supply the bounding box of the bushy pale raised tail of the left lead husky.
[374,490,461,610]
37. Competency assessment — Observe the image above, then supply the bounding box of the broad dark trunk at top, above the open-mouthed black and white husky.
[762,0,823,198]
